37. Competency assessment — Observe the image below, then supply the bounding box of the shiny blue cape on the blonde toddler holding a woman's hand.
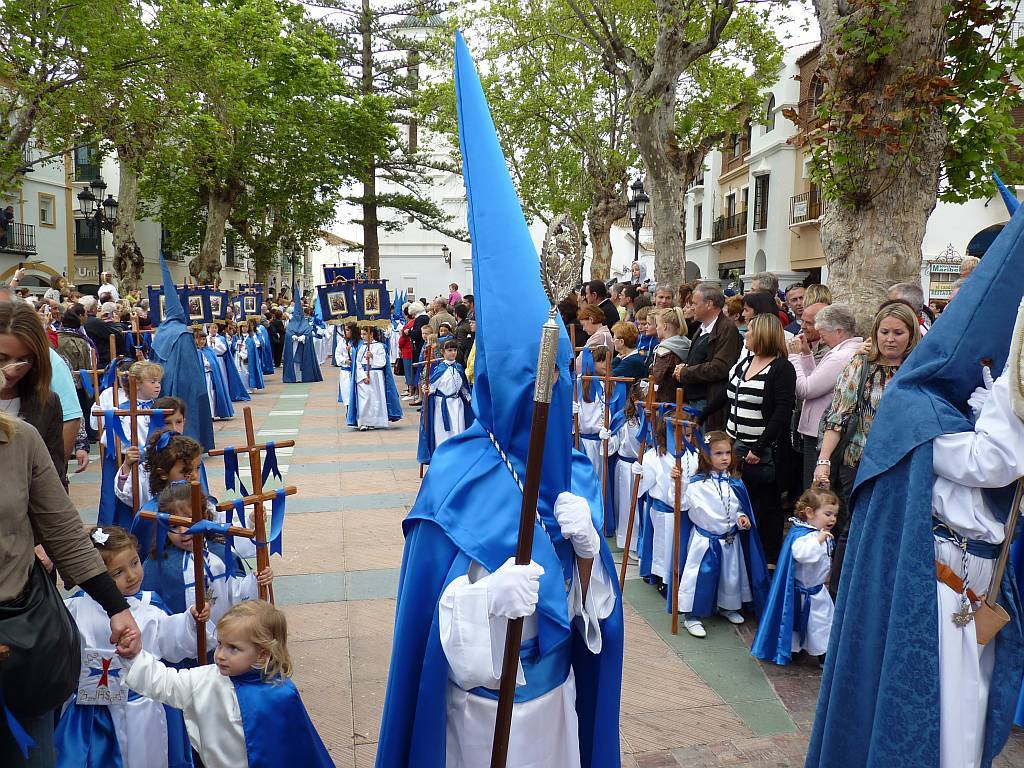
[231,670,334,768]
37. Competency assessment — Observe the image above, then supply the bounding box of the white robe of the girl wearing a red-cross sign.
[65,592,203,768]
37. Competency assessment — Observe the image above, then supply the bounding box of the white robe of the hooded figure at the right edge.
[932,372,1024,768]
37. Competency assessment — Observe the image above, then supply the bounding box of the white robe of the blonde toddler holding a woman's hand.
[125,642,249,768]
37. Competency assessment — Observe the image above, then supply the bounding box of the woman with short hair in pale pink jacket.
[790,304,864,488]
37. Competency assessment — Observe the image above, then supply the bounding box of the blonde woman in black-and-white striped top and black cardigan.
[701,314,797,562]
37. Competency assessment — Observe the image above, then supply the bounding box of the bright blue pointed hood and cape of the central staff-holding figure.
[377,35,623,768]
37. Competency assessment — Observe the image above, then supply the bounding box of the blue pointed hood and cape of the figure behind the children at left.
[153,256,216,451]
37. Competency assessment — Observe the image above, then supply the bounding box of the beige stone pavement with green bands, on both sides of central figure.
[72,367,1024,768]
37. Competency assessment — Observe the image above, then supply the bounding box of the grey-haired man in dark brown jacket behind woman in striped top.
[675,283,742,430]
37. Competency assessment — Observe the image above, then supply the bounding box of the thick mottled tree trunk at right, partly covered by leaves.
[815,0,946,331]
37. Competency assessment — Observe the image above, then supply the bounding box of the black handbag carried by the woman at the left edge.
[0,560,82,718]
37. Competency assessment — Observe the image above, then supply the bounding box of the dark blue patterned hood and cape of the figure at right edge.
[807,192,1024,768]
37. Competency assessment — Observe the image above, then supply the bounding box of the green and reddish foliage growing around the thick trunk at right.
[805,0,1024,208]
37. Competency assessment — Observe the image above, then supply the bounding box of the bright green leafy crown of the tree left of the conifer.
[136,0,392,270]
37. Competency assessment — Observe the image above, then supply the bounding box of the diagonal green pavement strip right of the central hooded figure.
[624,579,797,736]
